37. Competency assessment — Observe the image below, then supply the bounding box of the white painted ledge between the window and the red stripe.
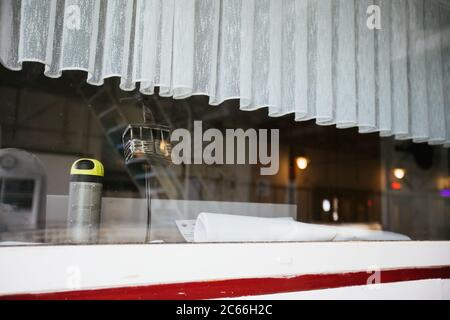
[0,241,450,295]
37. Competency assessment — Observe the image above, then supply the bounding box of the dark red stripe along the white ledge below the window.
[0,266,450,300]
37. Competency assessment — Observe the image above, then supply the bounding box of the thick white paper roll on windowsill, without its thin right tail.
[194,212,337,242]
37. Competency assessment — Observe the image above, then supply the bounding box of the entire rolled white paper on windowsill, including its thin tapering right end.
[194,212,411,242]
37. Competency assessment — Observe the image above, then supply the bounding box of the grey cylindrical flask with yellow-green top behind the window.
[67,159,104,243]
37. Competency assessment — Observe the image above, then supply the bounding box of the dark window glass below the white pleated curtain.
[0,64,450,244]
